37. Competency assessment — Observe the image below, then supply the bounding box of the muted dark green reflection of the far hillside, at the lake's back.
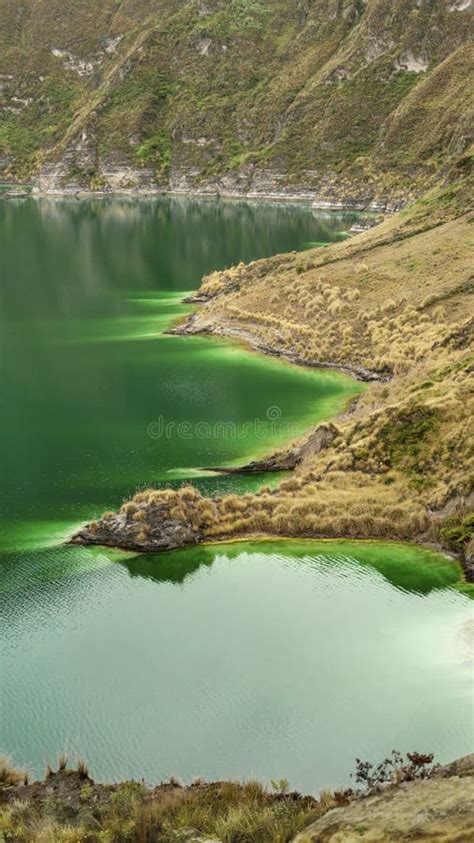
[0,197,355,317]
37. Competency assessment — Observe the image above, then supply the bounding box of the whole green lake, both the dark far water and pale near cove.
[0,198,472,790]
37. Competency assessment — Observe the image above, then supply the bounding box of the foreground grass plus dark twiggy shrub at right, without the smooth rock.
[0,751,464,843]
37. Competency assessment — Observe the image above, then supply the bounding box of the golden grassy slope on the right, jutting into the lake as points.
[79,180,474,568]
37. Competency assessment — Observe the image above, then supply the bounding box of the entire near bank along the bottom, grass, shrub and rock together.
[0,753,474,843]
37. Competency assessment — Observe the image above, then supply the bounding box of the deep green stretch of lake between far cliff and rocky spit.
[0,198,359,532]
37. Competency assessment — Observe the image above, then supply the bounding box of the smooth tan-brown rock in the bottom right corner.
[294,755,474,843]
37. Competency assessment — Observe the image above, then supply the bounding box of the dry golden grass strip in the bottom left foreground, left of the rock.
[0,771,322,843]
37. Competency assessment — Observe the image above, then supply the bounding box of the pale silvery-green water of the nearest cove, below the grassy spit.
[0,542,472,791]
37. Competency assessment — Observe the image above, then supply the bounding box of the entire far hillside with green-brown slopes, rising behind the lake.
[0,0,472,202]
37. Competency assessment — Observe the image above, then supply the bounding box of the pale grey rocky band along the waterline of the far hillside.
[15,153,412,213]
